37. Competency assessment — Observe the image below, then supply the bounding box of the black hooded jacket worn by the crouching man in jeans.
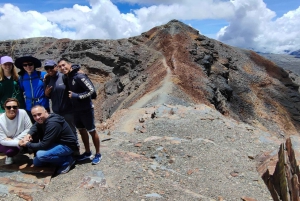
[26,113,78,151]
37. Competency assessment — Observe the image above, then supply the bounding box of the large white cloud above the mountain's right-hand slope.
[217,0,300,53]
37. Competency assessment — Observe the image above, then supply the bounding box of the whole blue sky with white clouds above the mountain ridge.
[0,0,300,53]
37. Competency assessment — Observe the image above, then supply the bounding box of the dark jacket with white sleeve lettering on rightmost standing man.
[67,65,95,111]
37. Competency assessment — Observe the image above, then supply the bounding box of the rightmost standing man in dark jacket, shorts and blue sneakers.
[58,58,102,165]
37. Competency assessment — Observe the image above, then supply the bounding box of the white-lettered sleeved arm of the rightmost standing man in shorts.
[69,74,95,99]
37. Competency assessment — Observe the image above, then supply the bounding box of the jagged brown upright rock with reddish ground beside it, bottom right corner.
[257,136,300,201]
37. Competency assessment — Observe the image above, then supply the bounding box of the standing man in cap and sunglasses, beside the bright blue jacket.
[44,60,79,150]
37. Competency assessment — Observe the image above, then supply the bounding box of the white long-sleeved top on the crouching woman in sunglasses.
[0,109,32,147]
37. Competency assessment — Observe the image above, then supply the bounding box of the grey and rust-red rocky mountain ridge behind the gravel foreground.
[0,20,300,136]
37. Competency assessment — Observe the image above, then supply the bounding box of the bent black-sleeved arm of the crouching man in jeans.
[26,122,62,150]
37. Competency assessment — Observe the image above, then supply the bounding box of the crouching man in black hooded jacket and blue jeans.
[19,105,78,174]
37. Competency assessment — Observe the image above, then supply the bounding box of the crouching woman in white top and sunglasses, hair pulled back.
[0,98,32,164]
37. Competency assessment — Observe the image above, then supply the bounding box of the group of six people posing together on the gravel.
[0,56,102,174]
